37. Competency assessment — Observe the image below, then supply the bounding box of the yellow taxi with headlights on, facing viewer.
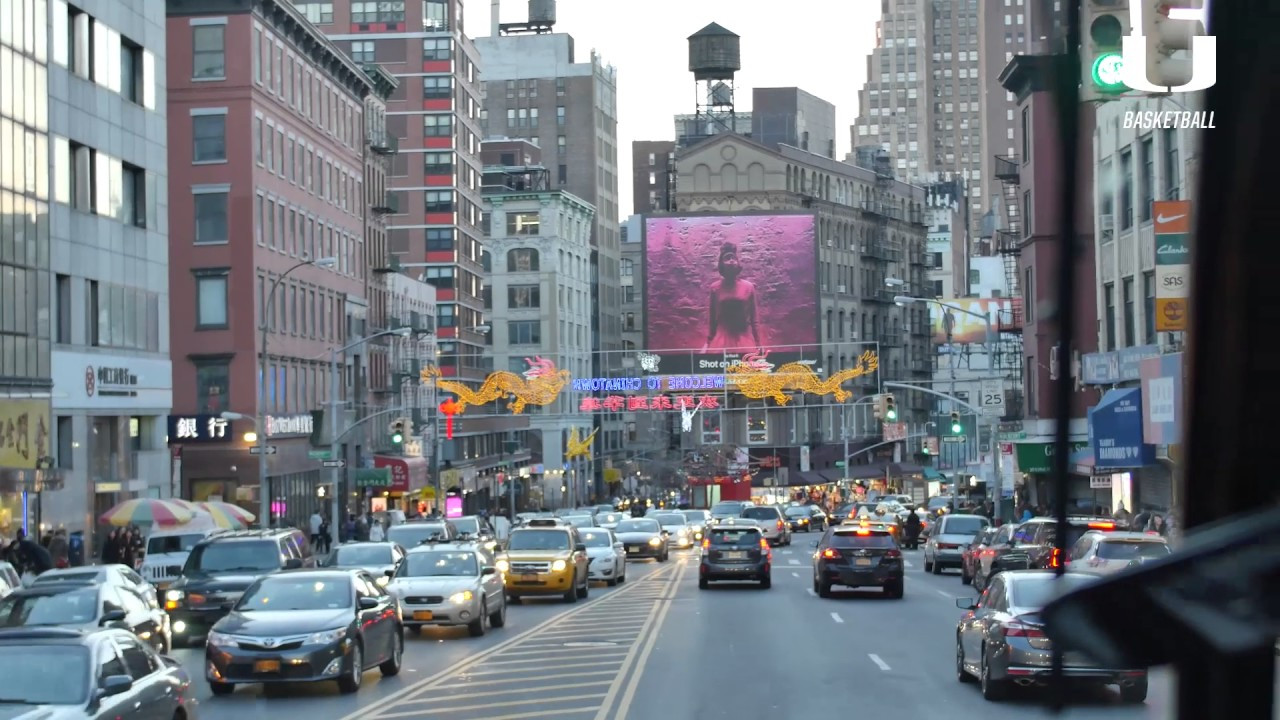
[497,518,590,602]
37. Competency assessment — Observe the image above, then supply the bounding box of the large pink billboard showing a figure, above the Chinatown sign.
[644,214,818,373]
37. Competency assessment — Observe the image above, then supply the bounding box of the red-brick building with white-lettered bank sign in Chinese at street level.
[168,0,374,521]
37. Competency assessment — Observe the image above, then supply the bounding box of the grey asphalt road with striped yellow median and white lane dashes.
[177,536,1280,720]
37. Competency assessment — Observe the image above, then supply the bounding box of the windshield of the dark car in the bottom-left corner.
[0,644,90,702]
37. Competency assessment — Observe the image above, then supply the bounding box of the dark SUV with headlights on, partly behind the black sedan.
[164,528,316,646]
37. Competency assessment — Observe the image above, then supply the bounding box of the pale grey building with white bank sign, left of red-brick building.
[42,0,171,547]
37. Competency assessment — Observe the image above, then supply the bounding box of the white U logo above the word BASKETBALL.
[1123,0,1217,92]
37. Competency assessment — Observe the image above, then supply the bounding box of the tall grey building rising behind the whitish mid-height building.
[476,12,623,489]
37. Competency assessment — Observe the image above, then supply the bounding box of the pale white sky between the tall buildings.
[463,0,879,220]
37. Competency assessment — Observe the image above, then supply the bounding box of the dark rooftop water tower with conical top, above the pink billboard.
[686,23,742,146]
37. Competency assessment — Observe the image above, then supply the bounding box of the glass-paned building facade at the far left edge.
[0,0,55,538]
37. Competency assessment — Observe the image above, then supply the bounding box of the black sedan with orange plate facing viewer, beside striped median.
[205,570,404,696]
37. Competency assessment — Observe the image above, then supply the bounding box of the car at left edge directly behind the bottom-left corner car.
[0,582,170,652]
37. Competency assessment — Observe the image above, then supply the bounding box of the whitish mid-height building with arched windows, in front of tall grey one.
[477,141,600,506]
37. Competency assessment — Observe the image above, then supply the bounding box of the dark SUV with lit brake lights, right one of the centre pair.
[813,525,905,600]
